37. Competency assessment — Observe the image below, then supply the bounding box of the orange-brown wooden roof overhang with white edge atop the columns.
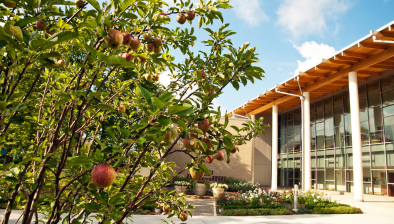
[228,21,394,116]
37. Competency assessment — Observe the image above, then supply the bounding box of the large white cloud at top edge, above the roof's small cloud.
[277,0,350,38]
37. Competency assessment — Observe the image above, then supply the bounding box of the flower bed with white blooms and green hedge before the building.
[217,187,363,215]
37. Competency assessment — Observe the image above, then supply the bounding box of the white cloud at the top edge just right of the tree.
[230,0,269,26]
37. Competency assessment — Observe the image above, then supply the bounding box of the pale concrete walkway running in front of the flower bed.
[0,191,394,224]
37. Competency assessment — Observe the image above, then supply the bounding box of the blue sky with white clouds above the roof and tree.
[155,0,394,114]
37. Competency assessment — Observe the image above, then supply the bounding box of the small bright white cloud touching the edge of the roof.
[293,41,335,75]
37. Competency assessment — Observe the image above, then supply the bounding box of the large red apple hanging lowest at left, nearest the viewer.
[91,164,116,188]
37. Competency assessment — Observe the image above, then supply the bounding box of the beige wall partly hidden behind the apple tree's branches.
[167,118,252,181]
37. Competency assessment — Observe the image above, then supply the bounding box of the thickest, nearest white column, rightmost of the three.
[349,72,364,201]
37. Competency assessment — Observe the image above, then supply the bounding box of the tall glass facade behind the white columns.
[278,75,394,197]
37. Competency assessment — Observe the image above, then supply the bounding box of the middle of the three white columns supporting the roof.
[302,92,312,191]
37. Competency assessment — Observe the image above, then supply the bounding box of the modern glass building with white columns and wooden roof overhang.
[229,21,394,201]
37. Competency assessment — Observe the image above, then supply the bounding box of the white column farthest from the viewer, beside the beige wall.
[271,105,278,190]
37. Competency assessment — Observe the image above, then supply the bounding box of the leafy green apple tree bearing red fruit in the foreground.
[0,0,264,224]
